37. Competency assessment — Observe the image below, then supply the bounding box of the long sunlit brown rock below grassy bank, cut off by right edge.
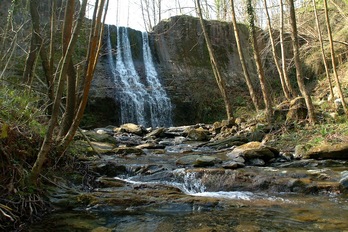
[303,144,348,160]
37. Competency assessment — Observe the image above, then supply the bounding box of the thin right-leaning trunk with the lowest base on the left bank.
[30,0,87,184]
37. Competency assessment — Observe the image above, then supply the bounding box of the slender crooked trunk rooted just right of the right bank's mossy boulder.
[288,0,316,124]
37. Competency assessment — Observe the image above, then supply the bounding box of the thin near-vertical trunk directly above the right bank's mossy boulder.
[279,0,296,97]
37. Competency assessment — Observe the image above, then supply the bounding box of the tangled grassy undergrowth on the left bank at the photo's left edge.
[0,82,46,231]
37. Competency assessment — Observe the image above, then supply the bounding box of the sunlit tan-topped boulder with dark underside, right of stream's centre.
[227,142,279,162]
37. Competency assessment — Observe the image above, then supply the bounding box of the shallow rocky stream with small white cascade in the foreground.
[29,128,348,232]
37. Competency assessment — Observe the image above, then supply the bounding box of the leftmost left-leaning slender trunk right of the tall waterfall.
[195,0,233,119]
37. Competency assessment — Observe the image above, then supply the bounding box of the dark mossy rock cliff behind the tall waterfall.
[87,16,275,125]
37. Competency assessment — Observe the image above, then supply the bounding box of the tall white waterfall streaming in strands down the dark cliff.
[107,27,172,127]
